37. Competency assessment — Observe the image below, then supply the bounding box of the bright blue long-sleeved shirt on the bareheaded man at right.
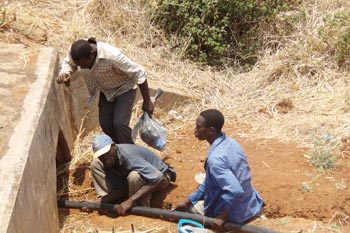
[188,133,264,223]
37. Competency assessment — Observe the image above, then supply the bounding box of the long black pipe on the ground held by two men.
[57,200,277,233]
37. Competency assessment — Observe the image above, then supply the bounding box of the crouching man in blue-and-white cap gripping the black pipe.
[91,134,176,215]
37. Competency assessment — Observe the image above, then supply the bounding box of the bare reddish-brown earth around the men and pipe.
[60,123,350,232]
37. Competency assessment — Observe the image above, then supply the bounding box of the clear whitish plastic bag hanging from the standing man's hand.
[131,112,167,151]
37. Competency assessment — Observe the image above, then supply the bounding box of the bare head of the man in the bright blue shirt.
[195,109,225,143]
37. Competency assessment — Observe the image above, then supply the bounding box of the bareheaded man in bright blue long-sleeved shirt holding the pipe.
[174,109,264,230]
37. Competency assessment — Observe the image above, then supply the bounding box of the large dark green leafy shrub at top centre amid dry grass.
[154,0,296,65]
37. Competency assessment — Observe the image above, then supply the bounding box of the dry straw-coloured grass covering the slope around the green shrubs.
[0,0,350,232]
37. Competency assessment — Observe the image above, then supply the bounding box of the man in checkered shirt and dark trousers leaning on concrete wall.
[56,38,154,144]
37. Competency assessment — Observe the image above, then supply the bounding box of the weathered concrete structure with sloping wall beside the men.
[0,43,187,233]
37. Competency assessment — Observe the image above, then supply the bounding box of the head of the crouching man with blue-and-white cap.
[91,134,116,167]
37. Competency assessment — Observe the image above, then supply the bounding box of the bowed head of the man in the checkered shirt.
[70,40,96,69]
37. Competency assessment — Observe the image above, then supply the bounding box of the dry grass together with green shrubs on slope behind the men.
[0,0,350,232]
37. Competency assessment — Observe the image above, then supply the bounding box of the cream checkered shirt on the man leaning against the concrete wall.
[60,42,146,103]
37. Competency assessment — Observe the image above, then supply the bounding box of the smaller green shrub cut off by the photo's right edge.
[319,10,350,66]
